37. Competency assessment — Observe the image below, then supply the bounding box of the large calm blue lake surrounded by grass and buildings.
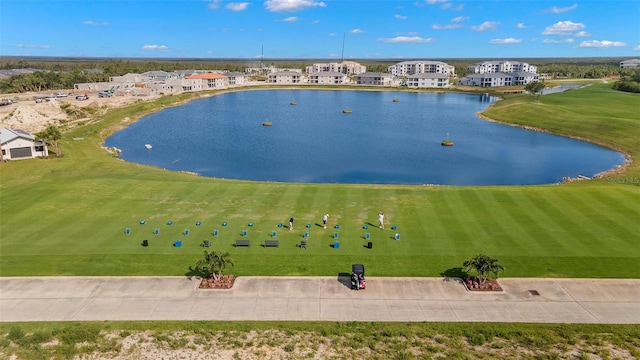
[105,90,624,185]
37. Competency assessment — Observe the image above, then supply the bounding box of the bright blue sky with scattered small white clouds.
[0,0,640,59]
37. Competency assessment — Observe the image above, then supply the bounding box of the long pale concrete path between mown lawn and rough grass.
[0,277,640,324]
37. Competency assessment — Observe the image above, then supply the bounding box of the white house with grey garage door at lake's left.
[0,128,49,160]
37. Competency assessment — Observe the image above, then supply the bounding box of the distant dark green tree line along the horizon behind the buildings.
[0,57,633,93]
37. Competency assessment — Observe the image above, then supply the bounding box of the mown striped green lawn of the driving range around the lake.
[0,84,640,278]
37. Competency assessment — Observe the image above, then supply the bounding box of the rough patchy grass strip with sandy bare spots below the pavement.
[0,321,640,360]
